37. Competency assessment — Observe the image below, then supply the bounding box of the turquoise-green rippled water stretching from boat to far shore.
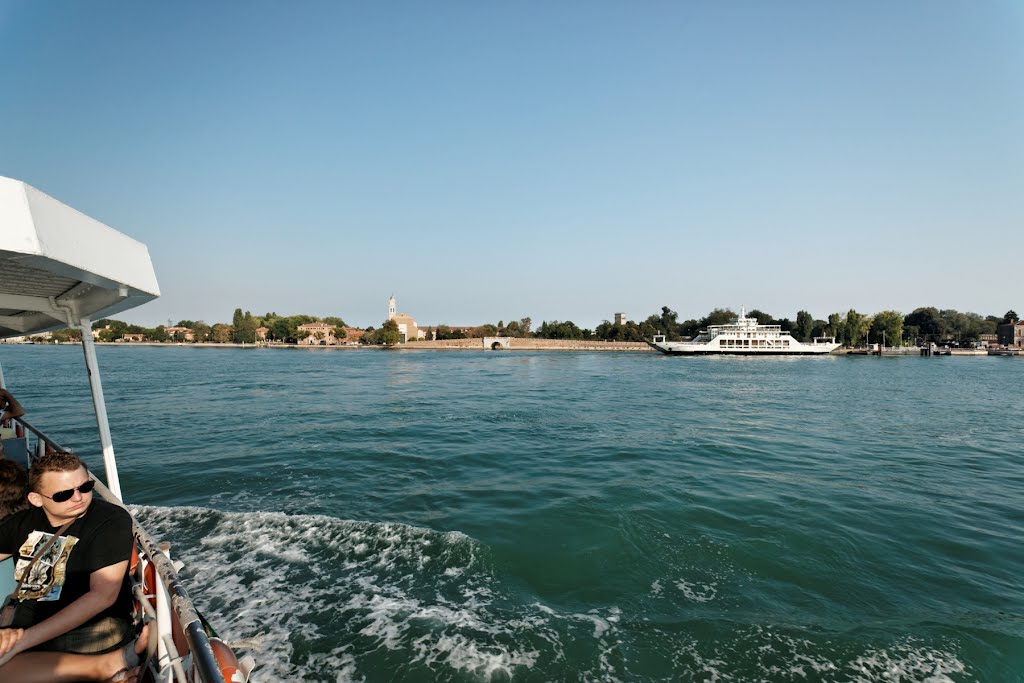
[0,346,1024,682]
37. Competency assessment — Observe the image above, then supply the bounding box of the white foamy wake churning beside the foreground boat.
[133,507,973,683]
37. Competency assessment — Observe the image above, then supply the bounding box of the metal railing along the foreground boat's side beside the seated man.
[8,418,225,683]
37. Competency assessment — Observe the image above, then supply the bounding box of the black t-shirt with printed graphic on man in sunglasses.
[0,499,134,629]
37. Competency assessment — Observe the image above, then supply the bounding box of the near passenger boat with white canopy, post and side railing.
[0,177,254,683]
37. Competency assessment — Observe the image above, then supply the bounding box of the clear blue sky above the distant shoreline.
[0,0,1024,327]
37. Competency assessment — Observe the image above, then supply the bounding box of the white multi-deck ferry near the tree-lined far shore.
[647,308,839,355]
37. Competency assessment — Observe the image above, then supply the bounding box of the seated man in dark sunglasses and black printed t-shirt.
[0,453,134,678]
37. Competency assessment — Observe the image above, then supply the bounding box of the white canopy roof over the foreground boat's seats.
[0,176,160,338]
